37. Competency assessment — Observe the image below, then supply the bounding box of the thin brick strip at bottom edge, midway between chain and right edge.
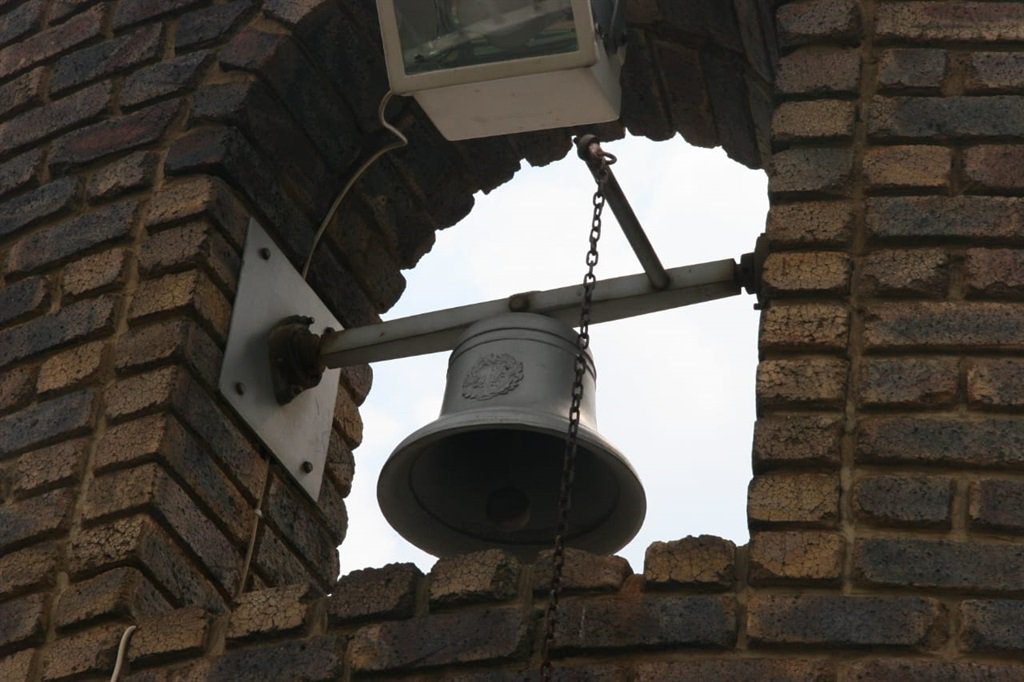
[634,658,836,682]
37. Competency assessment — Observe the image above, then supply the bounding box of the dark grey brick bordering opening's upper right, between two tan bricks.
[768,147,853,196]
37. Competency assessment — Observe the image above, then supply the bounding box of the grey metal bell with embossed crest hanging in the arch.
[377,313,647,561]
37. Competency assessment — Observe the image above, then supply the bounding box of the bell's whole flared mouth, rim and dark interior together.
[377,409,646,561]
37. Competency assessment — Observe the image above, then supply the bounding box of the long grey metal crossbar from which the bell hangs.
[319,259,740,369]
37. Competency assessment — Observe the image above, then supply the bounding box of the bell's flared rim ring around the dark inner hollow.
[377,408,647,559]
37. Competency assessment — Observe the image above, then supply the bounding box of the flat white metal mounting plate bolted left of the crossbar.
[219,220,341,502]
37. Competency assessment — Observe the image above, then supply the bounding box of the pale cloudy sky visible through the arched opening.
[339,137,768,574]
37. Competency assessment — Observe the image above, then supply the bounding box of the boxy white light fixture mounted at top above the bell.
[377,0,624,140]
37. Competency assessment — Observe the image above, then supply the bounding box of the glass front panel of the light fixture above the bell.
[394,0,579,75]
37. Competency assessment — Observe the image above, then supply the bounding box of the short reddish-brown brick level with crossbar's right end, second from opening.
[860,249,949,298]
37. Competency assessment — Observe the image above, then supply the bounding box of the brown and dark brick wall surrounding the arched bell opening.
[0,0,1024,681]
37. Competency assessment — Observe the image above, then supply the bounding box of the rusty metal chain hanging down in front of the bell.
[541,142,615,682]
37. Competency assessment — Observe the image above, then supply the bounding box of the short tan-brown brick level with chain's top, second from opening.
[863,144,952,189]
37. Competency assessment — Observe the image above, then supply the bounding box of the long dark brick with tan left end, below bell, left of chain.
[347,602,524,672]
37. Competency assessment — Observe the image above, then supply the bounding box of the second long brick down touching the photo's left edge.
[0,81,113,151]
